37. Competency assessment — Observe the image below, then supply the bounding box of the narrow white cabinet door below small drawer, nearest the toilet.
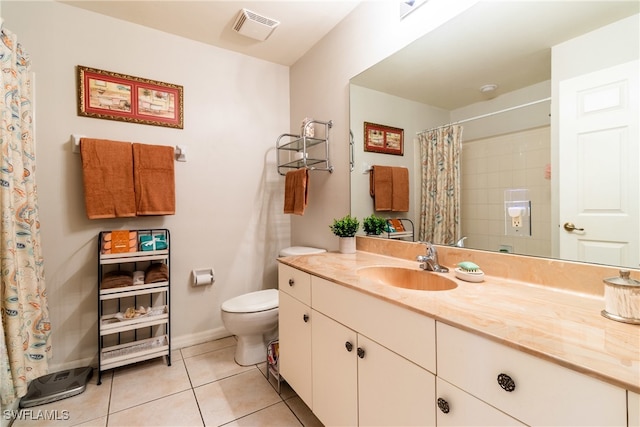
[278,291,312,408]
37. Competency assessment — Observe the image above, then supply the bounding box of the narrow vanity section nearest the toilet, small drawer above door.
[278,264,312,408]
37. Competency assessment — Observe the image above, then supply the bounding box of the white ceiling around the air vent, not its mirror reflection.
[60,0,360,66]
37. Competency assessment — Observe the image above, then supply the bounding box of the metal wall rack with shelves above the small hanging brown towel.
[276,120,333,176]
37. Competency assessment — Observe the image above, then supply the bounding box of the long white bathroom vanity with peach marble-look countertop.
[279,238,640,426]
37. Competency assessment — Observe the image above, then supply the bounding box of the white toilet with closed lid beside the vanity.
[221,246,326,366]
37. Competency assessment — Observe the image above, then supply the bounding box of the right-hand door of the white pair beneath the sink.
[358,335,436,426]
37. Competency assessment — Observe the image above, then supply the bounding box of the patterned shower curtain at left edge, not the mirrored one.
[0,22,51,405]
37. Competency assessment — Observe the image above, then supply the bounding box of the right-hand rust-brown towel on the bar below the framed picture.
[133,142,176,215]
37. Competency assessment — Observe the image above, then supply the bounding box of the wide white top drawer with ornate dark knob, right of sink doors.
[436,322,627,426]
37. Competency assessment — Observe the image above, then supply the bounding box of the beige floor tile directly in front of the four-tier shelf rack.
[109,359,191,413]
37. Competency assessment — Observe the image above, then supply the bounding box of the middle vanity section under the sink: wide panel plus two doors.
[312,276,435,426]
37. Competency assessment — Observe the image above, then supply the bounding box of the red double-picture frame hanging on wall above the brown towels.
[77,65,184,129]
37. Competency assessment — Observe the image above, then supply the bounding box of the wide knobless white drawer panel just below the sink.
[311,276,436,373]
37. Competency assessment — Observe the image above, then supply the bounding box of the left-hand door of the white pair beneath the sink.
[311,310,358,426]
